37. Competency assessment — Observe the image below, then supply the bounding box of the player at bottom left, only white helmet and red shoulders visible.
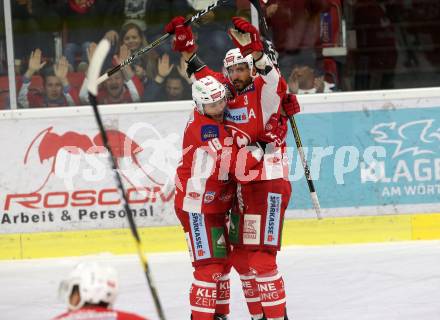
[53,262,147,320]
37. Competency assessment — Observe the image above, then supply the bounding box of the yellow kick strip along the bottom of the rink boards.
[0,213,440,260]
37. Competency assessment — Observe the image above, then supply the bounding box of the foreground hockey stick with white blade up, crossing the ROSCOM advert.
[87,39,165,320]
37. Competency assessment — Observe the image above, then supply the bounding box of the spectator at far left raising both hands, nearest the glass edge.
[18,49,79,108]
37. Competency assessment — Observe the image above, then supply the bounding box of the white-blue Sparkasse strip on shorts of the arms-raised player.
[264,192,281,246]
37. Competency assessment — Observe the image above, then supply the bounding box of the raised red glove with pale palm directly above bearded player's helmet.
[228,17,263,57]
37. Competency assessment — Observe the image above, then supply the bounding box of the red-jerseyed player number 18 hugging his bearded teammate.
[175,76,287,320]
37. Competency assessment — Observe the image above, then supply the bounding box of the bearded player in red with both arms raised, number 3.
[166,17,298,320]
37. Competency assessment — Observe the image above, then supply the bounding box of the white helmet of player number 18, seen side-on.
[192,76,226,114]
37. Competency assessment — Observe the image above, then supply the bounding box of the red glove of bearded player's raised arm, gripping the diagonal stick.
[165,16,196,52]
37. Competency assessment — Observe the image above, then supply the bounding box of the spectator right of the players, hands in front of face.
[287,65,334,94]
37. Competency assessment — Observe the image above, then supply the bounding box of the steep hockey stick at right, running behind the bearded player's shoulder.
[249,0,322,219]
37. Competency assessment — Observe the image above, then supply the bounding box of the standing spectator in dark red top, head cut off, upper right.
[263,0,340,85]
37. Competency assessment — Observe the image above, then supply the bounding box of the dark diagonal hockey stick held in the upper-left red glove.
[97,0,224,85]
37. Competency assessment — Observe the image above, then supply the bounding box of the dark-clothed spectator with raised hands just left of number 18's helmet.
[143,53,191,102]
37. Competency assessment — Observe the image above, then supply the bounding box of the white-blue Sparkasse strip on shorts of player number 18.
[189,212,211,260]
